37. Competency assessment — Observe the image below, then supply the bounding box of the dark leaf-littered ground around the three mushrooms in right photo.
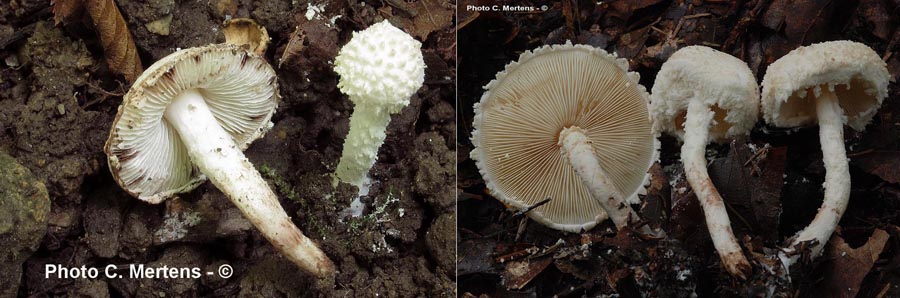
[457,0,900,297]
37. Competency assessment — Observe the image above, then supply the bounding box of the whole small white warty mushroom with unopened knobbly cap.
[334,20,425,194]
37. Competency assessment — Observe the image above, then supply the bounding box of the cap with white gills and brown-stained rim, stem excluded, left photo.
[104,44,279,204]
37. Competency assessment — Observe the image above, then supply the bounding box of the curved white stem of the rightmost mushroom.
[778,88,850,269]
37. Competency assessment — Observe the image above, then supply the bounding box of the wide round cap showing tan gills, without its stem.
[471,43,659,232]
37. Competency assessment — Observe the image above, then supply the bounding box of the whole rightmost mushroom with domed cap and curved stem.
[762,41,890,269]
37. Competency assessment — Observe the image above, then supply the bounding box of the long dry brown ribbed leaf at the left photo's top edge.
[84,0,144,82]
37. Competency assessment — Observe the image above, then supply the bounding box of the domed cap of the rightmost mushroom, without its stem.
[762,40,890,130]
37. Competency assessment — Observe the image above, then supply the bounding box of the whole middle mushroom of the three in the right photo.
[650,46,759,278]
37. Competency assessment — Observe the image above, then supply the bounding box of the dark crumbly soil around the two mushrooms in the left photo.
[0,0,457,297]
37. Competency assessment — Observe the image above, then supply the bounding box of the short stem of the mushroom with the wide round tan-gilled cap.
[559,126,640,230]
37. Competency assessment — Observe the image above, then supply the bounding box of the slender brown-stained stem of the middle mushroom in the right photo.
[681,100,751,279]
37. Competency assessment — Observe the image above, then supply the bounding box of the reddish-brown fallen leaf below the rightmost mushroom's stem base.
[820,229,890,298]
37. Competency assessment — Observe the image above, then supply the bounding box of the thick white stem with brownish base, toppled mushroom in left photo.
[165,89,334,278]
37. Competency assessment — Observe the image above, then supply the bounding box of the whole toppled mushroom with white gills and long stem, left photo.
[104,44,334,278]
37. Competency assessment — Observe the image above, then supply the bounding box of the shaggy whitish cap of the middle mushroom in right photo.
[650,46,759,142]
